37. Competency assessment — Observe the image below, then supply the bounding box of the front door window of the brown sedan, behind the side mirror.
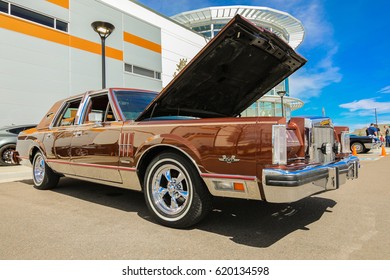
[82,94,116,124]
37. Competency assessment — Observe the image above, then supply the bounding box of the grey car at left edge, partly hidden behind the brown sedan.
[0,124,36,165]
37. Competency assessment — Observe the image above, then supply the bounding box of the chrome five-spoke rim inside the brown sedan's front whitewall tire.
[152,164,190,215]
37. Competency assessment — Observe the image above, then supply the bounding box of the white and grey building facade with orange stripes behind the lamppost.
[0,0,206,126]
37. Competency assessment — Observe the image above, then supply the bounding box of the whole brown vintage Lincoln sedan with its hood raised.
[13,16,359,228]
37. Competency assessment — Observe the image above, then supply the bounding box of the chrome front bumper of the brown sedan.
[262,156,359,203]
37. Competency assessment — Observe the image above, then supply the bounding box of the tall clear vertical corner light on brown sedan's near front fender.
[272,124,287,164]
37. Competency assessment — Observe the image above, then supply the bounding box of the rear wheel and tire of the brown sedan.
[33,152,60,190]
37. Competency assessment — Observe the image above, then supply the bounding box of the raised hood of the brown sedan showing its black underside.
[137,15,306,120]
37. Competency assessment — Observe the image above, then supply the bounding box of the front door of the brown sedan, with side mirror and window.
[71,92,123,183]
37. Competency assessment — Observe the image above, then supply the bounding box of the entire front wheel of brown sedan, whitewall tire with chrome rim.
[144,152,212,228]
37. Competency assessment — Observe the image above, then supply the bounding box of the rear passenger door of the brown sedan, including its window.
[43,97,81,175]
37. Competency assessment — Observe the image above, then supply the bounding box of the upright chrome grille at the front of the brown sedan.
[309,126,335,163]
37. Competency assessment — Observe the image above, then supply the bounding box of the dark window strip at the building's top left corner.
[0,0,68,32]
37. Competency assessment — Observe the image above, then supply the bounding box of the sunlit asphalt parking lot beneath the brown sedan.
[0,148,390,260]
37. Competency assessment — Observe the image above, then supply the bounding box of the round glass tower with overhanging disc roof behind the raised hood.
[171,6,305,118]
